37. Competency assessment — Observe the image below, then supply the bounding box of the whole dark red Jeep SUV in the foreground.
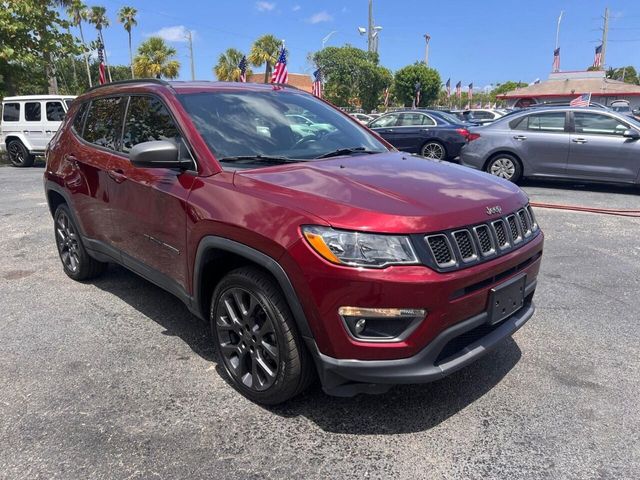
[44,80,543,404]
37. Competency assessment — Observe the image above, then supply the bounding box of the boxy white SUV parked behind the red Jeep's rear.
[0,95,76,167]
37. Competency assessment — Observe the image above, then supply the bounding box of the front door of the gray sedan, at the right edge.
[567,111,640,182]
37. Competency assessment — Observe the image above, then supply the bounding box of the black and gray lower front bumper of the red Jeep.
[307,280,537,396]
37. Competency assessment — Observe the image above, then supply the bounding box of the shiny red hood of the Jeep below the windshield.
[234,152,527,233]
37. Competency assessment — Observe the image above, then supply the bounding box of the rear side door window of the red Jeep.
[82,97,123,150]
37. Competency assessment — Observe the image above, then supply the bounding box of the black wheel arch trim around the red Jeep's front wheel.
[192,235,313,338]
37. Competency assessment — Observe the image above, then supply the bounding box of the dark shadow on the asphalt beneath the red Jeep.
[91,265,521,435]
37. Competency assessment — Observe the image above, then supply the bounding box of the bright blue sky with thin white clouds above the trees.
[79,0,640,88]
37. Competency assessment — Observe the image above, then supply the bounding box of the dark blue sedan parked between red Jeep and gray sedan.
[369,110,469,160]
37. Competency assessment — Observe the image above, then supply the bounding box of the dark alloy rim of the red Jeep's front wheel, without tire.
[215,287,280,391]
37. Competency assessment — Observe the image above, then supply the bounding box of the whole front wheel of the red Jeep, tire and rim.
[209,267,314,405]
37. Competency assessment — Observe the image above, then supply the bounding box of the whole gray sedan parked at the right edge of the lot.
[460,107,640,183]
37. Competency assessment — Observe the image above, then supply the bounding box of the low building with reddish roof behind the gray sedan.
[497,70,640,109]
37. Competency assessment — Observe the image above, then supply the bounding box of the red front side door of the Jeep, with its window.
[109,95,196,294]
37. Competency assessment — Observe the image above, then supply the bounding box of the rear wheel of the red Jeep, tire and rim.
[53,203,107,281]
